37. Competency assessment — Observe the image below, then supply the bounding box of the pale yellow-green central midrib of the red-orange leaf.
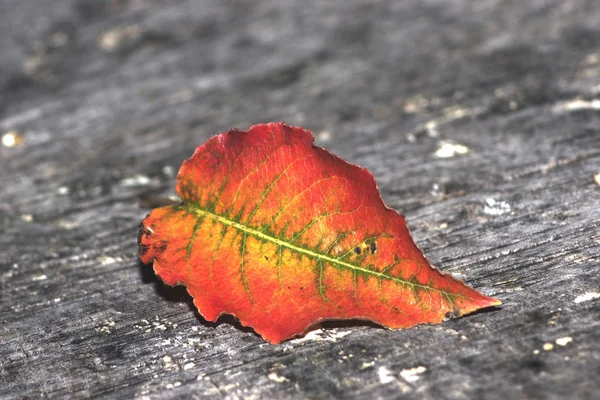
[183,204,463,300]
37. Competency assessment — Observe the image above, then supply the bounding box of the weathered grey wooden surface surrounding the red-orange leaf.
[0,0,600,399]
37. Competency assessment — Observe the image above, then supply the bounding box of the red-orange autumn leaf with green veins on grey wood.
[138,123,500,343]
